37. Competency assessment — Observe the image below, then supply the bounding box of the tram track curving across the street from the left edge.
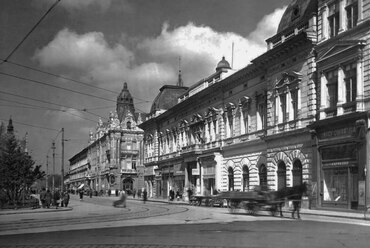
[0,204,189,235]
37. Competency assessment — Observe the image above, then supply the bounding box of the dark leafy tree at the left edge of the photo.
[0,135,45,206]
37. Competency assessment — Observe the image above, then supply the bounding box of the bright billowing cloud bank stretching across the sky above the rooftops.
[34,6,284,111]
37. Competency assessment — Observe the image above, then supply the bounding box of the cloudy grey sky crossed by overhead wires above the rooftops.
[0,0,291,174]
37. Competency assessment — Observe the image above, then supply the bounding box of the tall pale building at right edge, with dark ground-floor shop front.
[311,0,370,209]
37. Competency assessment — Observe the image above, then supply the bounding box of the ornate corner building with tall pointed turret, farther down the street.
[69,83,144,192]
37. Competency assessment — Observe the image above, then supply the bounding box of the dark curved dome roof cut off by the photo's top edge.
[277,0,317,33]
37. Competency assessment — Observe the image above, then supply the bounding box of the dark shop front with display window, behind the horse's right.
[316,115,367,209]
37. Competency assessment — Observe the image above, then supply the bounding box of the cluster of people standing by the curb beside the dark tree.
[40,188,70,208]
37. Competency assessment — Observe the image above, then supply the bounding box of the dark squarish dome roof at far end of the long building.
[150,85,188,113]
